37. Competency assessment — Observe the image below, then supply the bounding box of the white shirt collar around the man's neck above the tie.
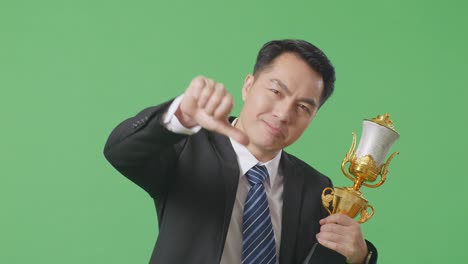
[229,118,283,186]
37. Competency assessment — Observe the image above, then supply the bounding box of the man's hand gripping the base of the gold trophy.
[317,214,368,264]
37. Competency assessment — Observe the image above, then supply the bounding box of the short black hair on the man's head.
[253,39,335,106]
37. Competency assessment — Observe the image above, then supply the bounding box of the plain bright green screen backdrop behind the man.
[0,0,468,264]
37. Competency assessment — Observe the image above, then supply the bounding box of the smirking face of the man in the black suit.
[236,53,323,159]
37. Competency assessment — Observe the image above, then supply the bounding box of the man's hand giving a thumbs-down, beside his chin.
[175,76,249,145]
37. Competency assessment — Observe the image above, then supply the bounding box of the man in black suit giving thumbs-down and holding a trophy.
[104,40,377,264]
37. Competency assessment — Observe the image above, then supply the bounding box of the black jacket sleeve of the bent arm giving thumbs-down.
[104,101,188,198]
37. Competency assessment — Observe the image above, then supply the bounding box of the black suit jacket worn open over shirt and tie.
[104,102,376,264]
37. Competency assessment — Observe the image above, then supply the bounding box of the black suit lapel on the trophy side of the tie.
[279,151,304,263]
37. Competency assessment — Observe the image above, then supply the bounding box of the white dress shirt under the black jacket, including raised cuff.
[163,95,283,264]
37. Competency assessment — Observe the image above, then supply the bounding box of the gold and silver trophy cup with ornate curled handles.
[322,114,400,224]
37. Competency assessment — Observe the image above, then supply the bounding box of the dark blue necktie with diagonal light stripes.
[242,165,276,264]
